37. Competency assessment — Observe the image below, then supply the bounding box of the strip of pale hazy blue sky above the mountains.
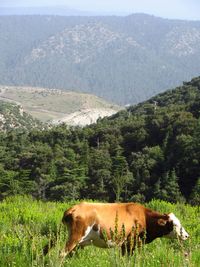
[0,0,200,20]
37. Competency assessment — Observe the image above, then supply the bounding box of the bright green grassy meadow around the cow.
[0,196,200,267]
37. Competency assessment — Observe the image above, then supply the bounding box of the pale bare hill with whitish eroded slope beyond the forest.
[0,86,120,123]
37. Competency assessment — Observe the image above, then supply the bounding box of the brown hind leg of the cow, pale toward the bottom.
[60,218,86,258]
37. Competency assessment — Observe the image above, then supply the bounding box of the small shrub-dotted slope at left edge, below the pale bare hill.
[0,100,43,132]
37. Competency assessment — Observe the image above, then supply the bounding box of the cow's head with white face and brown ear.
[160,213,189,240]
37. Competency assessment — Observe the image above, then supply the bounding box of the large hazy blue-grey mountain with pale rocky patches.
[0,14,200,104]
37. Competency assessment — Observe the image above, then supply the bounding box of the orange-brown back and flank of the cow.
[64,202,146,237]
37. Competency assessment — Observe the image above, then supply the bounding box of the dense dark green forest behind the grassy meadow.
[0,77,200,204]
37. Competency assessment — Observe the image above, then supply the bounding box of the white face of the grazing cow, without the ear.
[166,213,189,240]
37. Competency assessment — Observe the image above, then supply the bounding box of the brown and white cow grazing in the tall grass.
[61,202,189,257]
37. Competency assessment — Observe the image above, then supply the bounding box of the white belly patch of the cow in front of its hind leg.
[79,224,108,248]
